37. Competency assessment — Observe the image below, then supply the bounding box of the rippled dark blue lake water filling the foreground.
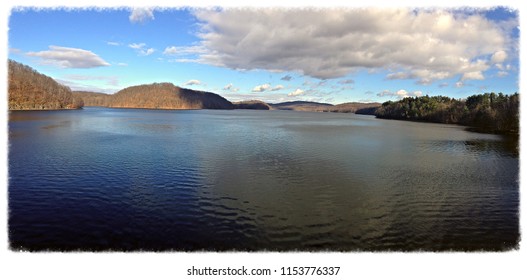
[8,108,519,251]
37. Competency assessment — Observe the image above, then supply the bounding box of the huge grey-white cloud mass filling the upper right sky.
[190,8,518,84]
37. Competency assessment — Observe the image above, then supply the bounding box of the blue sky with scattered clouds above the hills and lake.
[8,6,519,104]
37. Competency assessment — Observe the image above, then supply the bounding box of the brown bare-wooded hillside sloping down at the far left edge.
[8,60,83,110]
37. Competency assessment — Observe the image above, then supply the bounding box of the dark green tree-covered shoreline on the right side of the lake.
[375,93,520,134]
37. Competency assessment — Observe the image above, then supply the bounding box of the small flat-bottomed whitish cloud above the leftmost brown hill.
[26,46,110,68]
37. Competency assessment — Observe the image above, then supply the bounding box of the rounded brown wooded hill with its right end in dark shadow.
[104,83,234,109]
